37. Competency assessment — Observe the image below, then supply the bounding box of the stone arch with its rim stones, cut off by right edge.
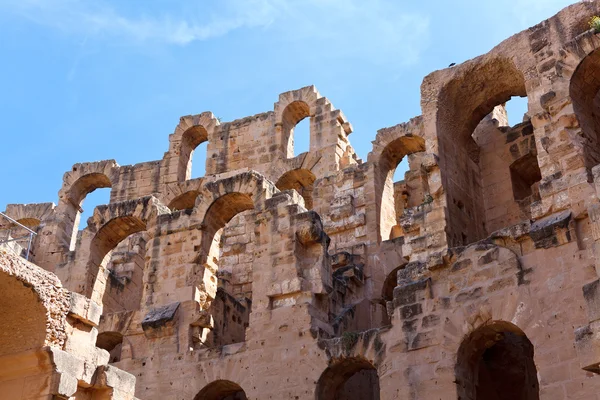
[563,31,600,180]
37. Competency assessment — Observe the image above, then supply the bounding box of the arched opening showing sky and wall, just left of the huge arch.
[375,136,428,240]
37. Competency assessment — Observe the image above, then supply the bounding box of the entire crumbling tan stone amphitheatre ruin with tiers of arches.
[5,1,600,400]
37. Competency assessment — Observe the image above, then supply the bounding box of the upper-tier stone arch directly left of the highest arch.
[166,111,220,182]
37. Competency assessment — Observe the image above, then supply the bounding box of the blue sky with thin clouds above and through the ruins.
[0,0,573,225]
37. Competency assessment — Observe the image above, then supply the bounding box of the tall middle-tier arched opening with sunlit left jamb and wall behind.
[200,193,254,347]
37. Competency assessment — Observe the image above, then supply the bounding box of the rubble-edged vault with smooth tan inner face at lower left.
[0,251,70,356]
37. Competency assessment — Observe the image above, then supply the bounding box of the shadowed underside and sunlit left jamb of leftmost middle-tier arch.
[85,215,146,308]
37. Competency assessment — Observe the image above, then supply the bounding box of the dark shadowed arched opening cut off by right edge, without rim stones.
[569,50,600,181]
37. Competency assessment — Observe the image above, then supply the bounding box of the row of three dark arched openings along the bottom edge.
[194,321,539,400]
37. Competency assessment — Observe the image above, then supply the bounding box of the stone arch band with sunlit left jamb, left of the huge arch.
[368,117,425,240]
